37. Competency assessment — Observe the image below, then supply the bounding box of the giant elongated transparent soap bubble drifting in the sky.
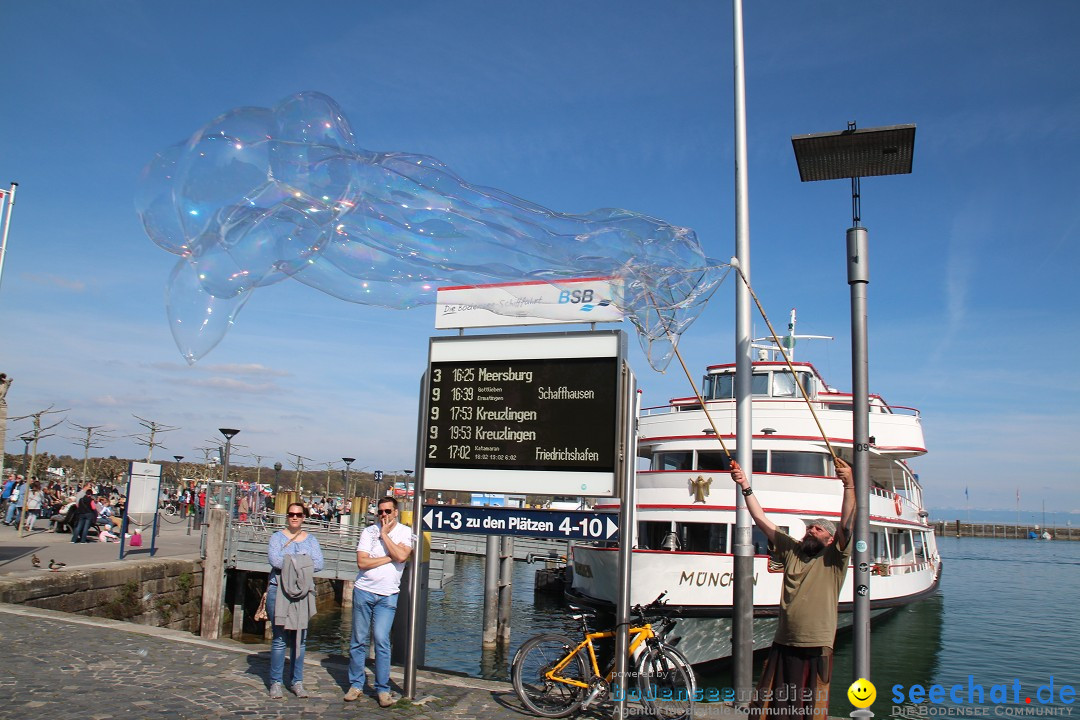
[136,92,726,369]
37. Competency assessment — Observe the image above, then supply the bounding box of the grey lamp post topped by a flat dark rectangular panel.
[792,122,915,679]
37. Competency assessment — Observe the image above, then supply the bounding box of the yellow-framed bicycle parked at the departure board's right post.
[511,593,697,720]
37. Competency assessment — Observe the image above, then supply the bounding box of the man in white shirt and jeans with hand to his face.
[345,498,413,707]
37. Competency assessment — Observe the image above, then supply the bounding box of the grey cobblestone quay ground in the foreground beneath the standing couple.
[0,606,548,720]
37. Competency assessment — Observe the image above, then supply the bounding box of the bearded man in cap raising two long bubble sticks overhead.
[731,458,855,718]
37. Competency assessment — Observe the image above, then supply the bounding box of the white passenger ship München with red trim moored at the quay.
[567,311,941,663]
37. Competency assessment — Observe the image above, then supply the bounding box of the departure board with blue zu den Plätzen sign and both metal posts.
[404,330,636,697]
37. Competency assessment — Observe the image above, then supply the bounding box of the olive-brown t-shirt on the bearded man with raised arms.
[773,530,851,648]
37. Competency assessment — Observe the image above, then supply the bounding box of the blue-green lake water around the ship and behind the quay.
[308,538,1080,718]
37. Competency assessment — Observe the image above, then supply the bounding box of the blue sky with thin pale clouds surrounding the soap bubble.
[0,0,1080,512]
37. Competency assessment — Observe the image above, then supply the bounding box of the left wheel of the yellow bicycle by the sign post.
[510,635,591,718]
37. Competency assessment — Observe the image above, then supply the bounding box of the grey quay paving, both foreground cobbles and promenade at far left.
[0,515,745,720]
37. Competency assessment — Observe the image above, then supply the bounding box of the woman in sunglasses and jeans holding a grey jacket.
[267,502,324,699]
